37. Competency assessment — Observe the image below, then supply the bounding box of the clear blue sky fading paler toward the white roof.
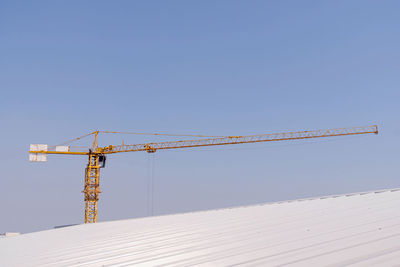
[0,0,400,232]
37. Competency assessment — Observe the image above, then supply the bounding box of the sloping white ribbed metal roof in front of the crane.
[0,189,400,266]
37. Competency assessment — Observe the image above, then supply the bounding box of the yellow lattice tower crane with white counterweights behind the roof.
[29,125,378,223]
